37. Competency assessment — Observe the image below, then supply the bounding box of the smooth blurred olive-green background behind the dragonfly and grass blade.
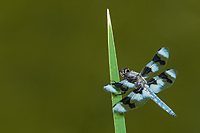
[0,0,200,133]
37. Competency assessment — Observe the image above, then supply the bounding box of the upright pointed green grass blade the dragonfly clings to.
[107,9,126,133]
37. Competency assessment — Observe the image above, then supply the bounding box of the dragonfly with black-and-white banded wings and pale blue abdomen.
[103,47,178,117]
